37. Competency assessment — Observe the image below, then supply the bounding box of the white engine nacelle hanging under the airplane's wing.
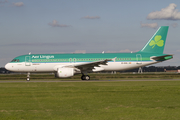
[56,68,74,78]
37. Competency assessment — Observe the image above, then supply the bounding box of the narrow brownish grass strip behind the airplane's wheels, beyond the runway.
[0,73,180,81]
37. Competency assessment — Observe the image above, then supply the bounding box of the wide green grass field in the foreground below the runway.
[0,81,180,120]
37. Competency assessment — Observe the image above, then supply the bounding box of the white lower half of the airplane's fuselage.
[5,61,158,72]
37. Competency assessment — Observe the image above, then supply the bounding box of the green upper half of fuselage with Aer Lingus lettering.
[11,53,170,63]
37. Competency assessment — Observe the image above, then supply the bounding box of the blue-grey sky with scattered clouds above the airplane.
[0,0,180,67]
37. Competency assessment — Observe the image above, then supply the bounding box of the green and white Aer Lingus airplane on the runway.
[5,26,173,81]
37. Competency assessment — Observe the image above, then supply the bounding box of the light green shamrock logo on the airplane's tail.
[149,35,164,48]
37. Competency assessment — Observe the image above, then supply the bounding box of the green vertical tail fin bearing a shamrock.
[139,26,169,53]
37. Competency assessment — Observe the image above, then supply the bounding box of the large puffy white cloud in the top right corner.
[147,3,180,20]
